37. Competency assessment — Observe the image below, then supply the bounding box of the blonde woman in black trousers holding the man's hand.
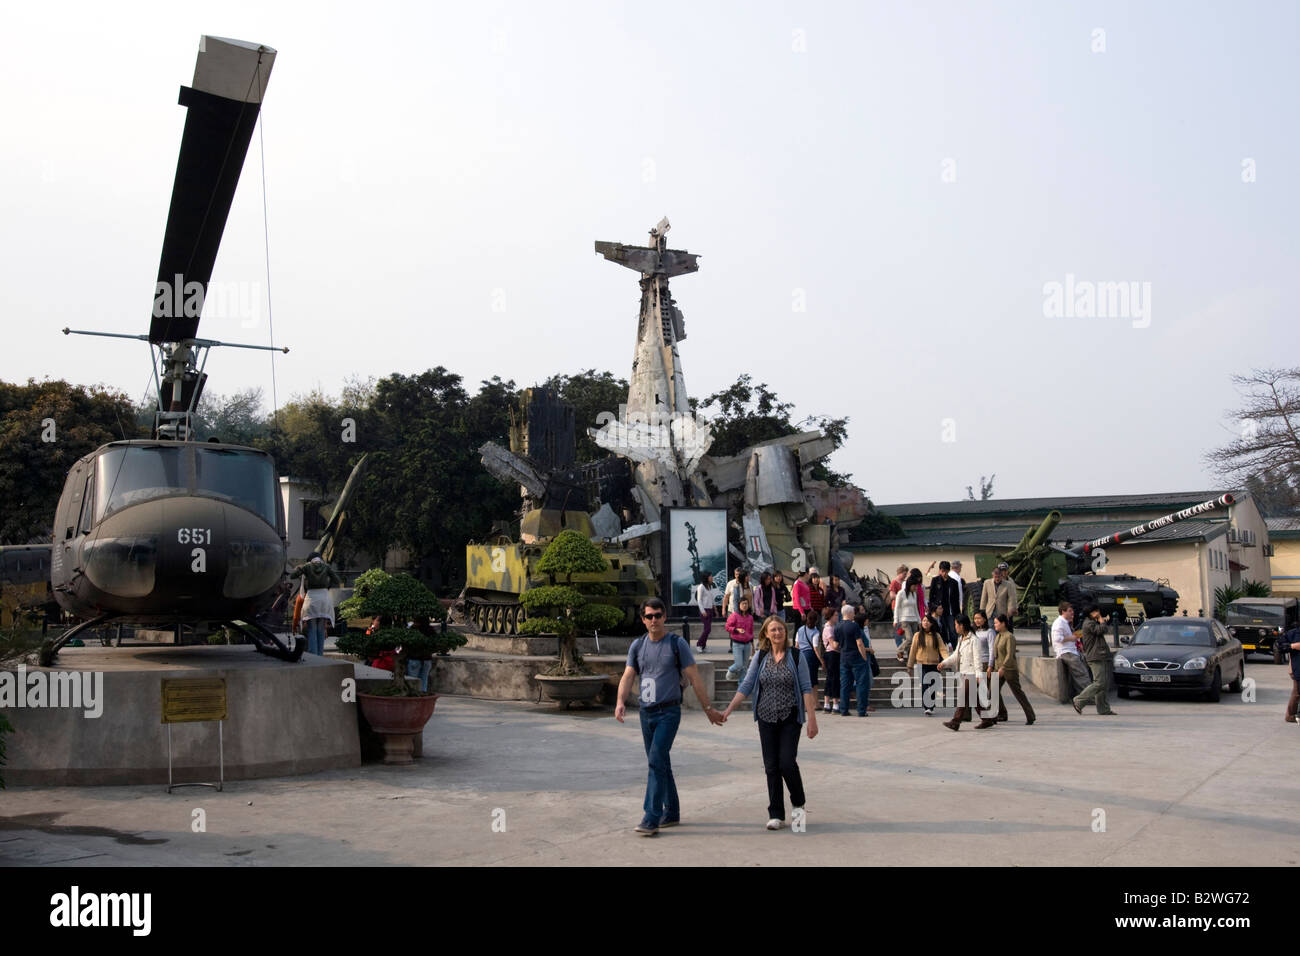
[723,615,818,830]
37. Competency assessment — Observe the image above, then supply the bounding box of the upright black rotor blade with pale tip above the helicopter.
[150,36,276,345]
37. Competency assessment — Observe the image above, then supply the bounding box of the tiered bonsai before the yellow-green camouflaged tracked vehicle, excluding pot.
[519,528,623,678]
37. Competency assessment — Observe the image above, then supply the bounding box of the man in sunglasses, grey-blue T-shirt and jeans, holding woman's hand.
[614,597,727,836]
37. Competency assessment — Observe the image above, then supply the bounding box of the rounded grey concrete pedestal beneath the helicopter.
[4,645,361,787]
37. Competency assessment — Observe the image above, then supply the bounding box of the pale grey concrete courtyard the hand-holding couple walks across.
[0,658,1300,866]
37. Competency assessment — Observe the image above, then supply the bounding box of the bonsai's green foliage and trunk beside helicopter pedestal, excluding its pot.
[338,567,467,697]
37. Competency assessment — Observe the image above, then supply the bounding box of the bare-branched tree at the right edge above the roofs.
[1205,368,1300,510]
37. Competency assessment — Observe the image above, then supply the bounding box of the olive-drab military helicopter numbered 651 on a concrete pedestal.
[39,36,306,666]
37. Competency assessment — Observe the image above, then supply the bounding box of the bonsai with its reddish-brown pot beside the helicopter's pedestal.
[338,568,465,763]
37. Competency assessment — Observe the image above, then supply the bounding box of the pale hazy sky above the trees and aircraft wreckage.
[0,1,1300,503]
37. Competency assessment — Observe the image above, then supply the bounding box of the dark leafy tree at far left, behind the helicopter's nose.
[0,378,147,544]
